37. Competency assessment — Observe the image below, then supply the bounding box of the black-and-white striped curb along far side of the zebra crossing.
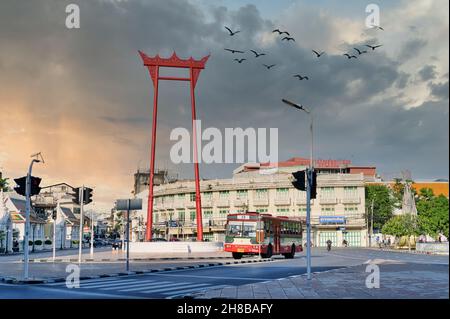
[0,257,274,285]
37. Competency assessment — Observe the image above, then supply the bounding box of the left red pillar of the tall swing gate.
[145,66,159,241]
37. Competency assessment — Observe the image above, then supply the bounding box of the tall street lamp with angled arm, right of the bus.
[281,99,314,280]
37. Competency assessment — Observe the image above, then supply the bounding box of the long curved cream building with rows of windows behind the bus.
[132,159,370,247]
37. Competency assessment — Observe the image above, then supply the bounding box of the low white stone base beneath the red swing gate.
[130,241,223,254]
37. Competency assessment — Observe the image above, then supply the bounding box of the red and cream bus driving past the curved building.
[224,212,303,259]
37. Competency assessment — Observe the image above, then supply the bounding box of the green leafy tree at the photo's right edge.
[416,188,449,237]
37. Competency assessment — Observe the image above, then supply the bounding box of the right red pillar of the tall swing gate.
[190,68,203,241]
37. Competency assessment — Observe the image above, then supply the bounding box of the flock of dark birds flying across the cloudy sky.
[221,25,384,81]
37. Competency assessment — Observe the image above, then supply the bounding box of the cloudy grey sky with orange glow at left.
[0,0,449,215]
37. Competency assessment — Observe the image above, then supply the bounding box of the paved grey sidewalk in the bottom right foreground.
[190,260,449,299]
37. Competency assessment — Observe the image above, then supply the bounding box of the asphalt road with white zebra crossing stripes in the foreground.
[0,248,448,299]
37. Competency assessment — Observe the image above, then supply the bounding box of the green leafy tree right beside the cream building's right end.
[365,185,394,229]
